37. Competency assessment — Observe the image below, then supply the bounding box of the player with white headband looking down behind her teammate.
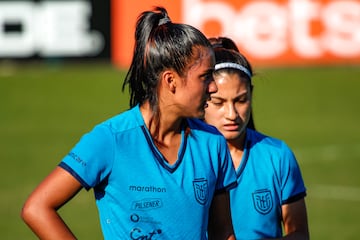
[205,38,309,239]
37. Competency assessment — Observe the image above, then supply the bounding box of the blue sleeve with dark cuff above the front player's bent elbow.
[59,125,114,190]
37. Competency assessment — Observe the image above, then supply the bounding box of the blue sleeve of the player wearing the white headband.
[281,143,306,204]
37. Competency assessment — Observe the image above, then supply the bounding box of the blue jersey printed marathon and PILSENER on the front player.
[60,106,236,240]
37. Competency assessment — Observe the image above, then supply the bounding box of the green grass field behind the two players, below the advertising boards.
[0,62,360,240]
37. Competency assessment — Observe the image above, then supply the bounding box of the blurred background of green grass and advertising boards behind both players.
[0,0,360,240]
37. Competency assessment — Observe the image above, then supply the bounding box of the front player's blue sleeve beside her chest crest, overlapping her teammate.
[216,138,237,192]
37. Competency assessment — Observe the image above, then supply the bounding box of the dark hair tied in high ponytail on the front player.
[122,7,211,110]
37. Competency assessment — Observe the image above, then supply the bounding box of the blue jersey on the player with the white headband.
[230,129,306,240]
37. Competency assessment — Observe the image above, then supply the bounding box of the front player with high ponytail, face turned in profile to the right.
[22,7,236,240]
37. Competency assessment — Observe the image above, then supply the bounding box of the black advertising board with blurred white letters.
[0,0,110,59]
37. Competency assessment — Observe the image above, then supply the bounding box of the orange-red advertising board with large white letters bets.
[111,0,360,67]
